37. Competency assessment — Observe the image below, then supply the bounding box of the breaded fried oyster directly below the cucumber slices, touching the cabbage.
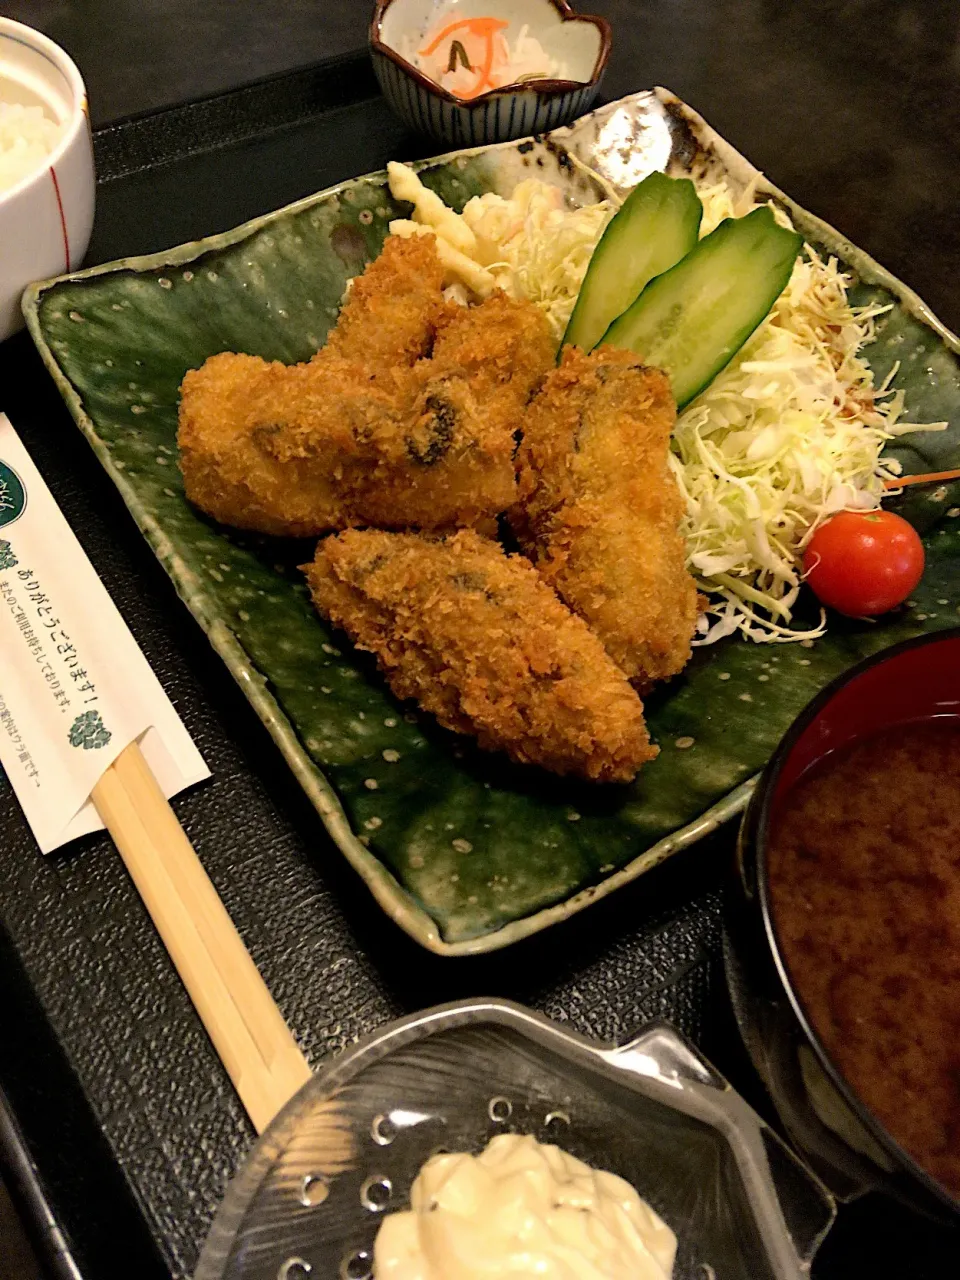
[511,347,698,689]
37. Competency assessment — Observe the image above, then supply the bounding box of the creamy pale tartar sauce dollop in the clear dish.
[374,1134,677,1280]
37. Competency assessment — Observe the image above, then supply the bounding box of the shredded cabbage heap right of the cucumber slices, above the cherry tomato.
[671,211,946,644]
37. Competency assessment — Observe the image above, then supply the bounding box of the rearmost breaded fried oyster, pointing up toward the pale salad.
[320,236,447,376]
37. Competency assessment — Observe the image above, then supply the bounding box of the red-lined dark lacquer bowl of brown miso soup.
[724,630,960,1225]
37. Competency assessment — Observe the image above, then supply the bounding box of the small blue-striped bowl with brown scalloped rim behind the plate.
[370,0,611,148]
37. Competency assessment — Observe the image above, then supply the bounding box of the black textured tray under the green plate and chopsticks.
[0,45,960,1280]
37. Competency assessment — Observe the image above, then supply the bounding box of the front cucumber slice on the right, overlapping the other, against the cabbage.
[603,206,804,408]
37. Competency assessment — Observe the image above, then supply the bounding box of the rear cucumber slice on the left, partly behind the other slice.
[563,173,703,351]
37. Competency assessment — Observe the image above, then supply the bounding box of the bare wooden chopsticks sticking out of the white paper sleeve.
[92,742,311,1133]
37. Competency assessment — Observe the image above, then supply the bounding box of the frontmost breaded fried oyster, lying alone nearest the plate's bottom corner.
[303,530,657,782]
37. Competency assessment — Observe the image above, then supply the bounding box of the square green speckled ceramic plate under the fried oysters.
[24,91,960,955]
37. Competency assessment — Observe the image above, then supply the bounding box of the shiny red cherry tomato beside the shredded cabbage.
[804,511,923,618]
